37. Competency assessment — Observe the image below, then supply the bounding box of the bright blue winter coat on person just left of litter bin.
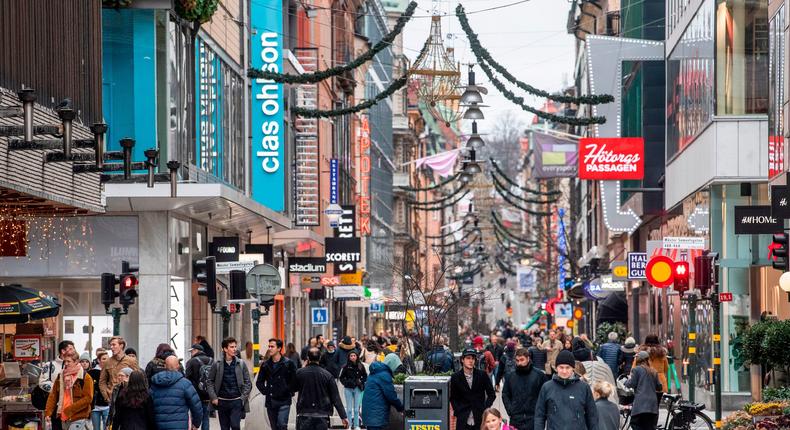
[362,362,403,428]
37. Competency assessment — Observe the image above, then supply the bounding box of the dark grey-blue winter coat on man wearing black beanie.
[534,375,598,430]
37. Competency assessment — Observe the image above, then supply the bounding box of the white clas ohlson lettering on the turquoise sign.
[255,32,281,173]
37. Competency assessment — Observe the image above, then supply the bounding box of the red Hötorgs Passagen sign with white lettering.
[579,137,645,181]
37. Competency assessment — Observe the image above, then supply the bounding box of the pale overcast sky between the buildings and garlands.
[403,0,574,132]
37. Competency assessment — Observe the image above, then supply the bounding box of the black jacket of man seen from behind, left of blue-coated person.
[291,363,347,419]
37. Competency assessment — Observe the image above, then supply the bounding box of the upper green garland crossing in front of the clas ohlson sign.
[247,1,417,84]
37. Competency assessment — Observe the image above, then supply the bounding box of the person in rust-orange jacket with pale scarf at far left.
[44,350,93,430]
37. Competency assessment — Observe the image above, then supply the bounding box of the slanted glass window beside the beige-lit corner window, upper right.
[666,0,714,159]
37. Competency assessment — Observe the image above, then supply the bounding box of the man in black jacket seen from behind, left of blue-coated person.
[292,346,348,430]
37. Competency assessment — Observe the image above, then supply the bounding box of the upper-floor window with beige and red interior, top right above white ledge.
[716,0,768,115]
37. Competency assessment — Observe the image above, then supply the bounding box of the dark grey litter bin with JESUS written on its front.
[403,376,450,430]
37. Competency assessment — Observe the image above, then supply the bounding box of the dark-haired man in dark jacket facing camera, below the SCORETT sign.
[255,338,296,430]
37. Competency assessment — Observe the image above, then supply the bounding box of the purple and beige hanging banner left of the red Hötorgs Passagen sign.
[532,133,579,179]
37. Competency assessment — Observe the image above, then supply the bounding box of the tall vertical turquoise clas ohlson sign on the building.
[250,0,286,211]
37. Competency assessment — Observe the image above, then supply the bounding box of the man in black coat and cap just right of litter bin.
[450,348,496,430]
